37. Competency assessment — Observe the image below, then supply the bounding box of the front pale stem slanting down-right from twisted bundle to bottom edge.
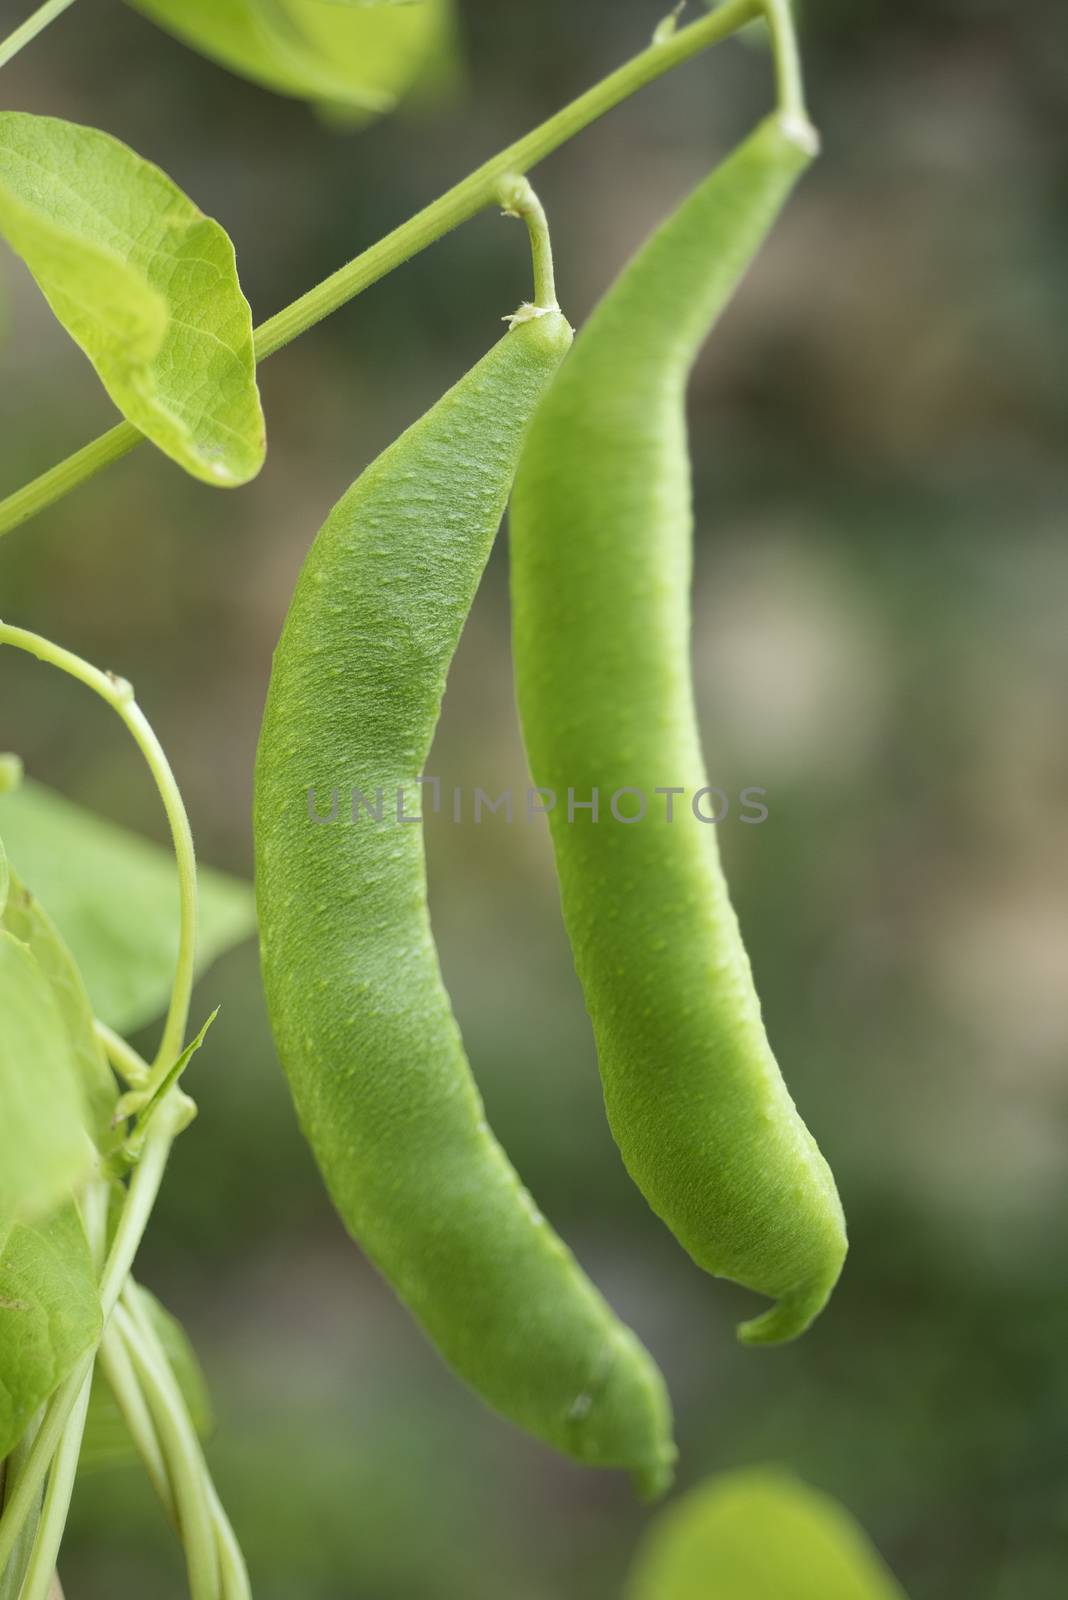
[115,1283,219,1600]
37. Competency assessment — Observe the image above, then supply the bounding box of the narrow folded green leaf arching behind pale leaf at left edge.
[0,869,117,1149]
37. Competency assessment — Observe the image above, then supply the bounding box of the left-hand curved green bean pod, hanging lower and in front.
[254,310,675,1494]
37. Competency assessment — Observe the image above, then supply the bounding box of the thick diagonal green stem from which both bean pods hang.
[0,0,767,534]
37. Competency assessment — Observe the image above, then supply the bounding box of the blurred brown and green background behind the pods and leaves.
[0,0,1068,1600]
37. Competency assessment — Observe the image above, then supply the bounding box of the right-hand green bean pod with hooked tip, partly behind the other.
[512,117,846,1342]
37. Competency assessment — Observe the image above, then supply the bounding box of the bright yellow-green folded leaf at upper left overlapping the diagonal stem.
[0,110,265,486]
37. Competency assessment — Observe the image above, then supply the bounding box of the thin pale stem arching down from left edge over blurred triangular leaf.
[0,622,197,1072]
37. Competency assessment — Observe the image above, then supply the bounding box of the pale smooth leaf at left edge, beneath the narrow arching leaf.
[0,930,93,1224]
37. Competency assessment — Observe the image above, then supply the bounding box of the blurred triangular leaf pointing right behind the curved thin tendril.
[0,781,256,1034]
